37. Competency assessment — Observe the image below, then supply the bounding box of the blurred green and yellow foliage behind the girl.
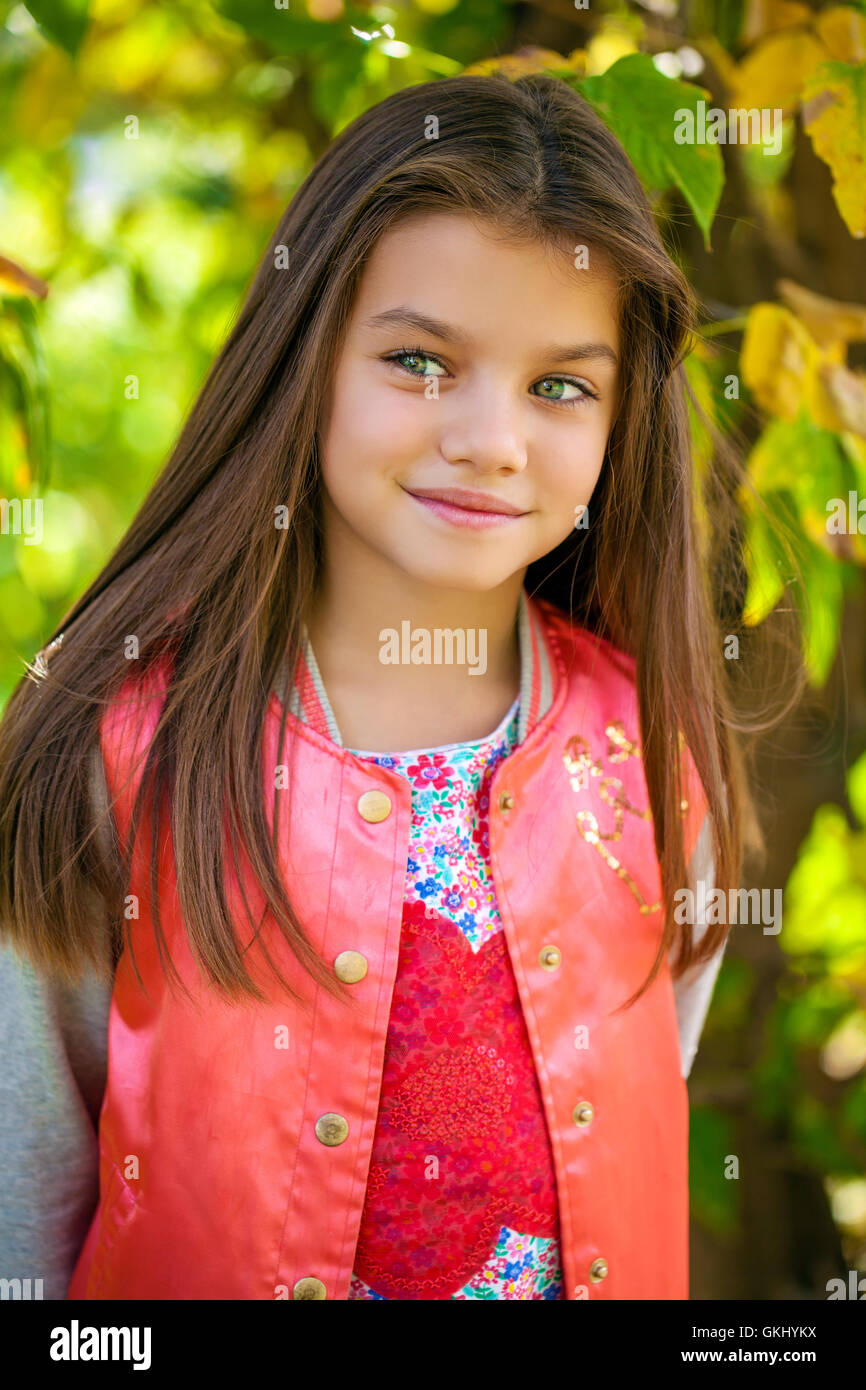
[0,0,866,1300]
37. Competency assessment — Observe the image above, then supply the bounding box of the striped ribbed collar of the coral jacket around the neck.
[275,588,555,748]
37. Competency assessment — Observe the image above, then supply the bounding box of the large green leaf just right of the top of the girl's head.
[575,53,724,250]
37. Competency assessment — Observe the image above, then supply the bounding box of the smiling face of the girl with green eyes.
[318,213,620,592]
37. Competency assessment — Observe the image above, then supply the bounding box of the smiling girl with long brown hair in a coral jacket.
[0,74,772,1300]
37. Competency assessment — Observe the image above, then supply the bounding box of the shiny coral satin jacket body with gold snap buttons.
[68,595,706,1300]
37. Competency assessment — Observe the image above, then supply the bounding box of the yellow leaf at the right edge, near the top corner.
[803,63,866,236]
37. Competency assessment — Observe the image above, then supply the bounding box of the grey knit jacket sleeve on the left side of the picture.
[0,758,113,1298]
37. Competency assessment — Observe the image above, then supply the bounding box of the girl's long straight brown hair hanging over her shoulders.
[0,72,800,1002]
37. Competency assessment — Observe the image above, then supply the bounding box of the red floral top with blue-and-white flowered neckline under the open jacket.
[349,701,562,1300]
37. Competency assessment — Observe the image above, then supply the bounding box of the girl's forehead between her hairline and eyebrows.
[352,211,619,349]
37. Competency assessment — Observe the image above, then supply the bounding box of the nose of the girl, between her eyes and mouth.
[439,382,528,473]
